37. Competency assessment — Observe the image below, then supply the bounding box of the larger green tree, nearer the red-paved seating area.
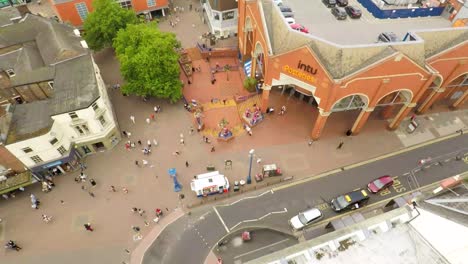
[114,23,182,102]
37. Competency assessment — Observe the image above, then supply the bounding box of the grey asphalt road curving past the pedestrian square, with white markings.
[143,135,468,264]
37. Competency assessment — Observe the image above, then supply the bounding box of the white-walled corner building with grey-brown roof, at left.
[0,12,120,176]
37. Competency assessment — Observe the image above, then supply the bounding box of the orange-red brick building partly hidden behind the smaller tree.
[49,0,169,27]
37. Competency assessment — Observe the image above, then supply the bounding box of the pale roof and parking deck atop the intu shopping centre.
[261,0,468,79]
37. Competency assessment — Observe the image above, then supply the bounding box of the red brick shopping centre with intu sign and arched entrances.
[238,0,468,139]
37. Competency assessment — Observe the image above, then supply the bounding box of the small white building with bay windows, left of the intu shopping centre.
[203,0,238,38]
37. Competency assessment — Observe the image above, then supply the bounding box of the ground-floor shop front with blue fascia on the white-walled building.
[31,148,81,178]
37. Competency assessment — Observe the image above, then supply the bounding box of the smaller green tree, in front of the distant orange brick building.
[83,0,138,51]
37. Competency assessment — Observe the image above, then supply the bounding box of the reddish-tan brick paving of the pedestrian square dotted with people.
[0,2,468,264]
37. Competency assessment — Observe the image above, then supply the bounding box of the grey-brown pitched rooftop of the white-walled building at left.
[0,10,100,144]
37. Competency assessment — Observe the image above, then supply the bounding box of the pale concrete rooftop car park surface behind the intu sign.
[276,0,451,45]
